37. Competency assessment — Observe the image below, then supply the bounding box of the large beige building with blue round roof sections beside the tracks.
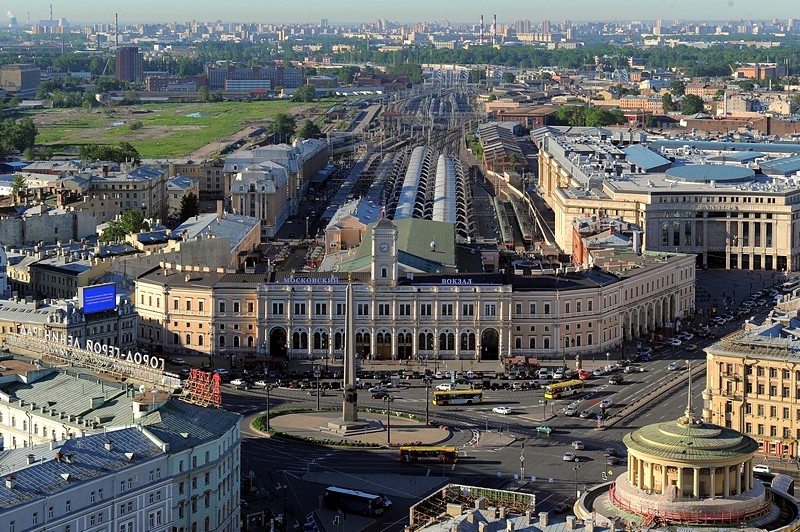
[534,127,800,271]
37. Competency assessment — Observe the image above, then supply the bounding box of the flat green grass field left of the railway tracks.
[29,101,318,158]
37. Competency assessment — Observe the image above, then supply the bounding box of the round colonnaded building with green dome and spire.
[575,376,798,530]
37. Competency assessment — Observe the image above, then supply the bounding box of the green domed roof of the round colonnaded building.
[622,420,759,464]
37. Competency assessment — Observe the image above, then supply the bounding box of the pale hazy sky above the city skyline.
[6,0,800,24]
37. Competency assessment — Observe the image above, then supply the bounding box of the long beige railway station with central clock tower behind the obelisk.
[136,220,694,361]
